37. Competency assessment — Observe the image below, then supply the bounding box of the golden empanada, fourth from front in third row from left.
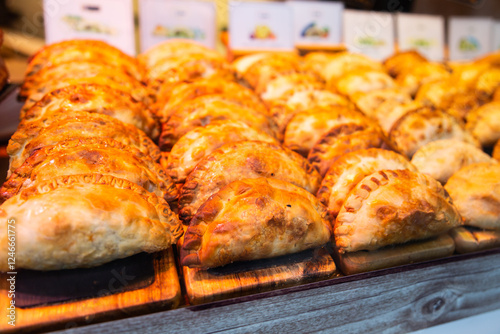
[283,106,369,157]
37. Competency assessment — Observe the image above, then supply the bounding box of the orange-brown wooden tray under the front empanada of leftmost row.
[0,248,181,333]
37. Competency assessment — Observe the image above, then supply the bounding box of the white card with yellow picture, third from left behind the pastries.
[229,1,294,51]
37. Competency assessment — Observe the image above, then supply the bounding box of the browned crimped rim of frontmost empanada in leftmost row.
[19,173,184,244]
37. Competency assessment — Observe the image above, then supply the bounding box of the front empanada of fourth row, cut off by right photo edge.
[445,162,500,230]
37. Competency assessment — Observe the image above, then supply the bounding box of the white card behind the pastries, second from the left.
[139,0,216,52]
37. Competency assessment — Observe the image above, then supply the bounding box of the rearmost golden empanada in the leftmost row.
[25,39,144,80]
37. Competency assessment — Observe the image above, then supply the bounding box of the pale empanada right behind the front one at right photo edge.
[411,139,493,184]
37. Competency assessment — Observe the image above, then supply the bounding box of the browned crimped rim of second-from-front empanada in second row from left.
[178,140,321,224]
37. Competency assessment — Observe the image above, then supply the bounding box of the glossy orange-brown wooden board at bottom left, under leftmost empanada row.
[0,248,181,333]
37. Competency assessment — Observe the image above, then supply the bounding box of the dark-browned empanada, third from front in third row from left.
[307,123,394,177]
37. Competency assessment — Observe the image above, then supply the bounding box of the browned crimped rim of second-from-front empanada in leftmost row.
[0,138,178,203]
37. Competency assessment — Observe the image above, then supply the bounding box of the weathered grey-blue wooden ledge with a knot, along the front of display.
[51,249,500,334]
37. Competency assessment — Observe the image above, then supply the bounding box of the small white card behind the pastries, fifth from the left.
[344,10,394,60]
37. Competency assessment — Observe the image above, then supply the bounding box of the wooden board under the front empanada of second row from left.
[182,248,340,305]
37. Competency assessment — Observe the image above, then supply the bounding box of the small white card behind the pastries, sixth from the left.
[396,13,444,61]
